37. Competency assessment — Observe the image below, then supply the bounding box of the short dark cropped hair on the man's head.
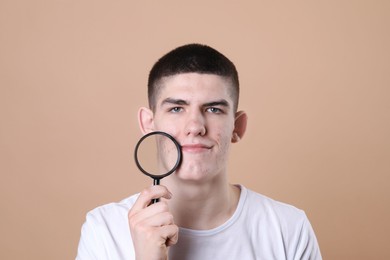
[148,43,240,111]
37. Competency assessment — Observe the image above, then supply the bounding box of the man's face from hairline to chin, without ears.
[153,73,235,181]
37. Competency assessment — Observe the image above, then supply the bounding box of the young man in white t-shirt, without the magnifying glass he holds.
[77,44,321,260]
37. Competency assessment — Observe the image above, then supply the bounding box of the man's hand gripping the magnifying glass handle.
[128,185,179,260]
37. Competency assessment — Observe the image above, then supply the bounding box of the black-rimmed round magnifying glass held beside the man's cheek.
[134,131,182,203]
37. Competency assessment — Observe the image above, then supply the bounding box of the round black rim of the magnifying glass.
[134,131,182,180]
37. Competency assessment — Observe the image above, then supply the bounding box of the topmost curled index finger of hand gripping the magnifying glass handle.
[129,185,172,215]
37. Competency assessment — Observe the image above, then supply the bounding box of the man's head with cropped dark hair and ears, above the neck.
[138,44,247,181]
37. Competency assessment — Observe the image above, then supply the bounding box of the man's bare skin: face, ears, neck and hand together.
[129,73,247,259]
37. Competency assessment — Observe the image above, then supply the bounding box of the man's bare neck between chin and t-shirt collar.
[163,175,240,230]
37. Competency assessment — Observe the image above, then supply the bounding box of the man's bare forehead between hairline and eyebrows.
[156,73,233,106]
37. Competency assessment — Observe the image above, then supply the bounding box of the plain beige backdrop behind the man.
[0,0,390,260]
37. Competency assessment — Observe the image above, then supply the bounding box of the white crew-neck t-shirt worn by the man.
[76,186,322,260]
